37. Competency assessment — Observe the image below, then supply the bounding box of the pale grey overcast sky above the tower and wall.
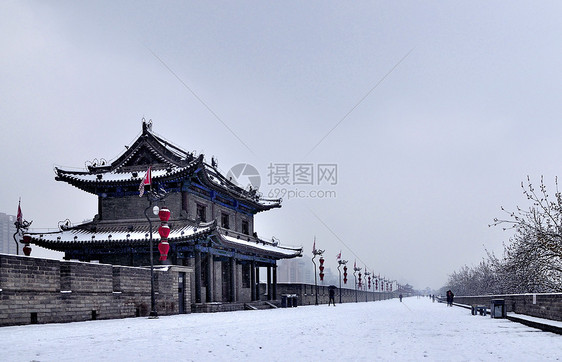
[0,1,562,288]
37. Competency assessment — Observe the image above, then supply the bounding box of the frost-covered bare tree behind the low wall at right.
[445,177,562,295]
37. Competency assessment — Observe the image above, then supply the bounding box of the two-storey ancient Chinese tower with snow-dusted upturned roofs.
[25,121,302,303]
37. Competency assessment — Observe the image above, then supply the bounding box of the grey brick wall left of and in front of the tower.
[0,254,193,326]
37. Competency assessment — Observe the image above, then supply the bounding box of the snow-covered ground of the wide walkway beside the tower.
[0,297,562,361]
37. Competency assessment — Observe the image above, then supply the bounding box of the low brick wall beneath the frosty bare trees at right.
[454,293,562,321]
